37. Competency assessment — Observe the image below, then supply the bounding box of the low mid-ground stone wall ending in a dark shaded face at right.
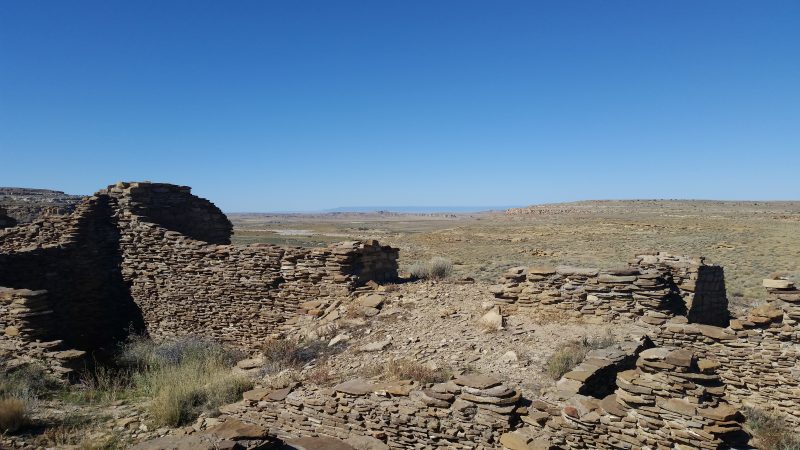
[491,253,728,325]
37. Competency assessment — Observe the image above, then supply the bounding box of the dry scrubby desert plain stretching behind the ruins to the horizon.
[230,200,800,309]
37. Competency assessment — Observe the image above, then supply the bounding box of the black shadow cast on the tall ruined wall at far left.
[0,197,144,357]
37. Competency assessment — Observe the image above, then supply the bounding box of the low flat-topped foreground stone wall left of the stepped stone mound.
[230,375,520,449]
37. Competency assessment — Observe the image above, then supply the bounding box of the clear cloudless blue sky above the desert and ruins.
[0,0,800,211]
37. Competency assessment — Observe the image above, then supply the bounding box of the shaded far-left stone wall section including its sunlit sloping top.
[0,197,142,352]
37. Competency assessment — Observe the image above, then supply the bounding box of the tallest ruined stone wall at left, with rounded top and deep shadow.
[0,179,398,362]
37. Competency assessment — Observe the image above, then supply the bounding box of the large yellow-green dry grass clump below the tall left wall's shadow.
[115,337,252,426]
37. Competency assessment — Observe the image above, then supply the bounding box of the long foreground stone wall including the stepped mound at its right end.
[223,343,748,450]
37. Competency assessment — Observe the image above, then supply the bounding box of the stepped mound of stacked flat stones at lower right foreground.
[515,347,748,450]
